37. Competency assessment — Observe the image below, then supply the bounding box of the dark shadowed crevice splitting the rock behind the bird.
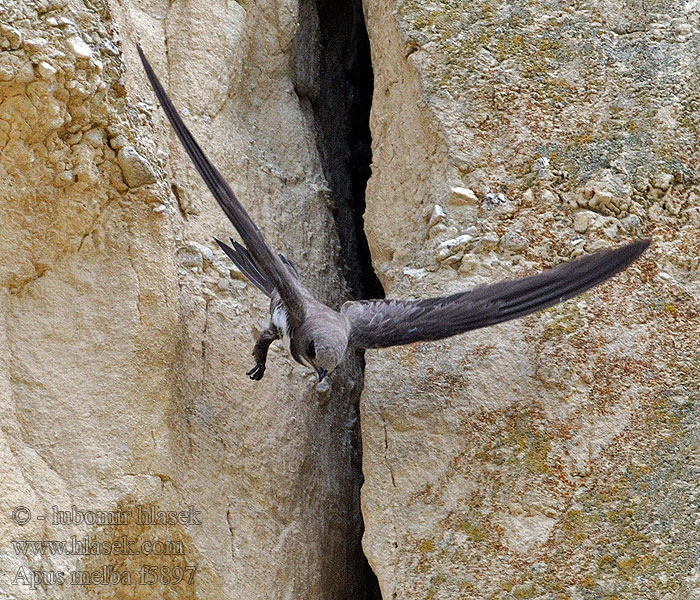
[295,0,384,600]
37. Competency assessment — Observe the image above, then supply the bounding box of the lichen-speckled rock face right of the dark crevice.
[361,0,700,599]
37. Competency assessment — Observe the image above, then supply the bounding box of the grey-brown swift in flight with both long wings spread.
[137,45,651,383]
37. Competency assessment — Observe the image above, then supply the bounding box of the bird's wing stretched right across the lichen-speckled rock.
[341,240,649,348]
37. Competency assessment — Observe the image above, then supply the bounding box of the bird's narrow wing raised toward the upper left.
[137,46,304,321]
